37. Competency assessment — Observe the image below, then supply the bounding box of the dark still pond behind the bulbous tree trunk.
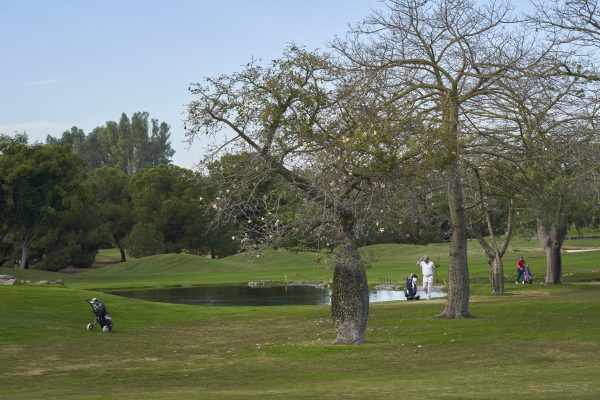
[108,286,446,306]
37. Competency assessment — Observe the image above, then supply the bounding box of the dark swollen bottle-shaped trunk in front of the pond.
[331,209,369,344]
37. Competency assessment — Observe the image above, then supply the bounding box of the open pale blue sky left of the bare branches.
[0,0,381,168]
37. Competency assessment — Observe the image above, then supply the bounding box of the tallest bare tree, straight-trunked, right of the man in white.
[336,0,523,318]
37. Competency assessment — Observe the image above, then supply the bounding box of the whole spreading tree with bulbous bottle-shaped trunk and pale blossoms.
[186,46,414,344]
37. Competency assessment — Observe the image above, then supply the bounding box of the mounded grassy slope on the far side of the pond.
[5,234,600,289]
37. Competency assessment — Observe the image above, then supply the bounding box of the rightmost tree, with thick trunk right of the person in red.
[474,46,600,284]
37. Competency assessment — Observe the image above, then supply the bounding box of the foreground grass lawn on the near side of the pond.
[0,284,600,399]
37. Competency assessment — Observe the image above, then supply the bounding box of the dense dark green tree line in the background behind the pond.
[0,113,447,270]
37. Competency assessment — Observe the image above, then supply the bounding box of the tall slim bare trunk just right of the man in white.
[438,161,469,318]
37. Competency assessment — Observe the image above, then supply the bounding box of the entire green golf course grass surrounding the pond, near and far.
[0,239,600,400]
